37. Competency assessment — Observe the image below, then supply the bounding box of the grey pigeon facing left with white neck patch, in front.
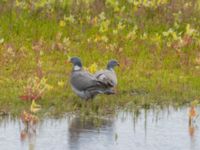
[70,57,107,100]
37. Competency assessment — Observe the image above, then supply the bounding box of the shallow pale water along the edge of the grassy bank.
[0,108,200,150]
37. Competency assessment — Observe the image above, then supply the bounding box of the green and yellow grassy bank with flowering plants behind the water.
[0,0,200,115]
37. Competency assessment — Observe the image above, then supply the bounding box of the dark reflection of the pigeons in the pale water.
[68,117,114,149]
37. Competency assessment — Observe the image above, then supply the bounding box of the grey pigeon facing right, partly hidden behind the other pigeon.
[95,60,119,94]
